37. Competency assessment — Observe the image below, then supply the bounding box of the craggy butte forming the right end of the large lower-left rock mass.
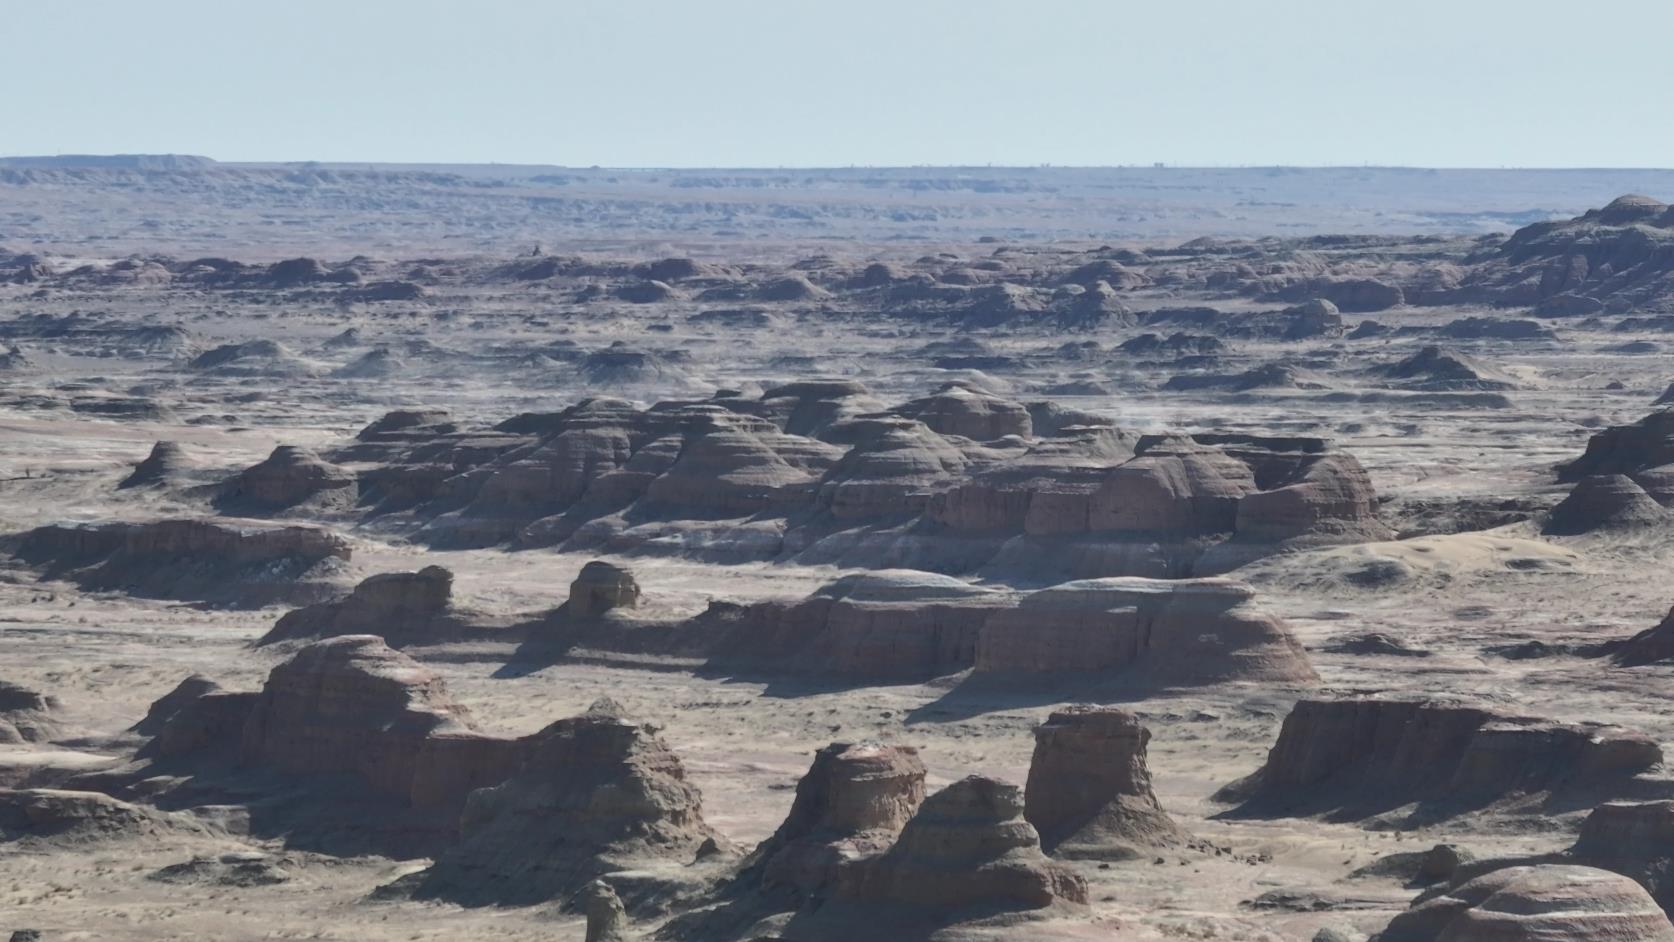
[413,708,725,905]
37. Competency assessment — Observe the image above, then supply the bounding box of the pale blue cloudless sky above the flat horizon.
[13,0,1674,167]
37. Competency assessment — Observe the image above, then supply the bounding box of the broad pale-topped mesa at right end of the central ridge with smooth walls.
[974,577,1317,686]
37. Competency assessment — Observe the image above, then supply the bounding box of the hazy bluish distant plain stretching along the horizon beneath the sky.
[0,156,1674,259]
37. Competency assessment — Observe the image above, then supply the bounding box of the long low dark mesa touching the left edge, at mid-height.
[7,519,352,607]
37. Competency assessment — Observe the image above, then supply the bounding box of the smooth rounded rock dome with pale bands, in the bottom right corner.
[1373,863,1674,942]
